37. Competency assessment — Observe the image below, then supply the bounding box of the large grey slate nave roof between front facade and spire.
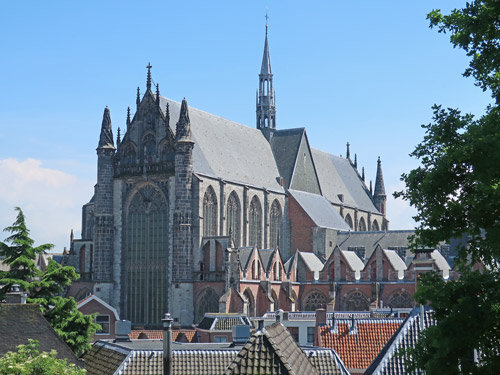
[160,97,284,192]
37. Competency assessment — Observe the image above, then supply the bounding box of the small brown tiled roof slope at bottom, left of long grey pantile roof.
[83,344,128,375]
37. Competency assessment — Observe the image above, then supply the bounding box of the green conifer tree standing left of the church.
[0,207,99,354]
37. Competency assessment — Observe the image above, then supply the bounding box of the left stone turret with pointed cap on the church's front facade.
[93,107,115,295]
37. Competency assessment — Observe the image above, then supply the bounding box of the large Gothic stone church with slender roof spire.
[65,25,436,327]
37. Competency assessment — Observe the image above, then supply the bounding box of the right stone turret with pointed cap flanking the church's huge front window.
[170,98,194,325]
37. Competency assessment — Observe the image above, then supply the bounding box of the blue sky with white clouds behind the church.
[0,0,490,250]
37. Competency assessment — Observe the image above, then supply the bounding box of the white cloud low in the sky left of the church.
[0,158,93,251]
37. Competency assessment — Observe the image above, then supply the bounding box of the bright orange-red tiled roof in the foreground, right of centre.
[319,318,404,369]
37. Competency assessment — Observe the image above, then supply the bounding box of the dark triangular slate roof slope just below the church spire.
[271,128,305,187]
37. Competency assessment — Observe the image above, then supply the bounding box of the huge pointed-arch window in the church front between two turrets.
[125,184,168,326]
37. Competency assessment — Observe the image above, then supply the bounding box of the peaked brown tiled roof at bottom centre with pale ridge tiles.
[225,322,319,375]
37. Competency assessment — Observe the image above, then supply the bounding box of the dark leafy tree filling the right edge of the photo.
[395,0,500,374]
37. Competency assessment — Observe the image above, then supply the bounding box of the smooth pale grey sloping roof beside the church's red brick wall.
[288,189,351,231]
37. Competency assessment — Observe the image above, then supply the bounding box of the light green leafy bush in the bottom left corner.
[0,340,87,375]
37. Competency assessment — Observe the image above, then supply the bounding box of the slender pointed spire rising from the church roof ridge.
[257,18,276,133]
